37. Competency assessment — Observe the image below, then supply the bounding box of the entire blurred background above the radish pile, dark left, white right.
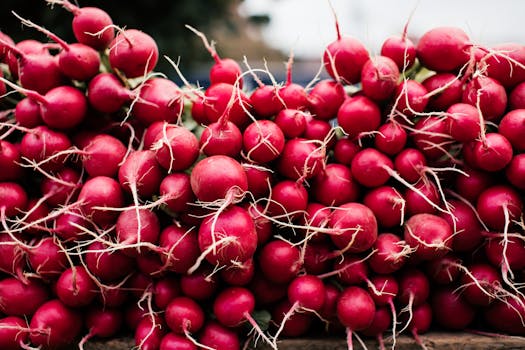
[0,0,525,86]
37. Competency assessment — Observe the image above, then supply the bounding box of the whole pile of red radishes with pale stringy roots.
[0,0,525,350]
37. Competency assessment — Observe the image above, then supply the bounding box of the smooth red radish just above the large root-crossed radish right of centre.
[311,163,360,206]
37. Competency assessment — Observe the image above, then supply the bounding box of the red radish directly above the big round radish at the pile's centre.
[199,117,243,158]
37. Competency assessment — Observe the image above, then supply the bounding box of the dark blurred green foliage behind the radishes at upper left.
[0,0,242,75]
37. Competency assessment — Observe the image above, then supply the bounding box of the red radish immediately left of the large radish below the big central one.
[159,225,200,273]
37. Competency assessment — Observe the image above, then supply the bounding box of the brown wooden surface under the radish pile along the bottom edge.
[85,333,525,350]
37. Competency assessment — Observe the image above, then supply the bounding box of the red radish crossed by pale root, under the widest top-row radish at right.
[422,72,463,111]
